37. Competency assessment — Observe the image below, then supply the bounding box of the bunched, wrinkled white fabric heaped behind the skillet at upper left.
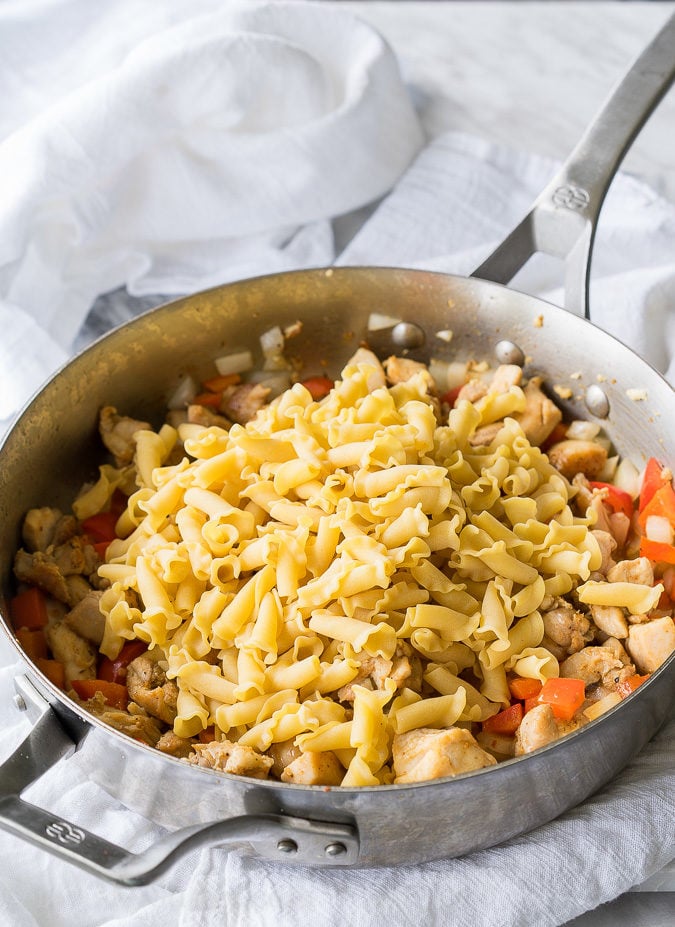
[0,0,422,419]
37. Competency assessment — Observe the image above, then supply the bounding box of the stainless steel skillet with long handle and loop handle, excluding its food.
[0,12,675,885]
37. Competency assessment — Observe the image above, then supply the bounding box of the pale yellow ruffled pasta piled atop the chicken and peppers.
[84,364,660,786]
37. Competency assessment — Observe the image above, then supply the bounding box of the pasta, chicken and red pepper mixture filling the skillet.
[6,338,675,786]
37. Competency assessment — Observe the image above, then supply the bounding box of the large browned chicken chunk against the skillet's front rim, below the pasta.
[392,727,497,785]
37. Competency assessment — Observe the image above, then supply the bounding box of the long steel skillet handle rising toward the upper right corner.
[471,15,675,318]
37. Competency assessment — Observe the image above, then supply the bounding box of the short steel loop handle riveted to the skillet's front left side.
[0,676,359,886]
